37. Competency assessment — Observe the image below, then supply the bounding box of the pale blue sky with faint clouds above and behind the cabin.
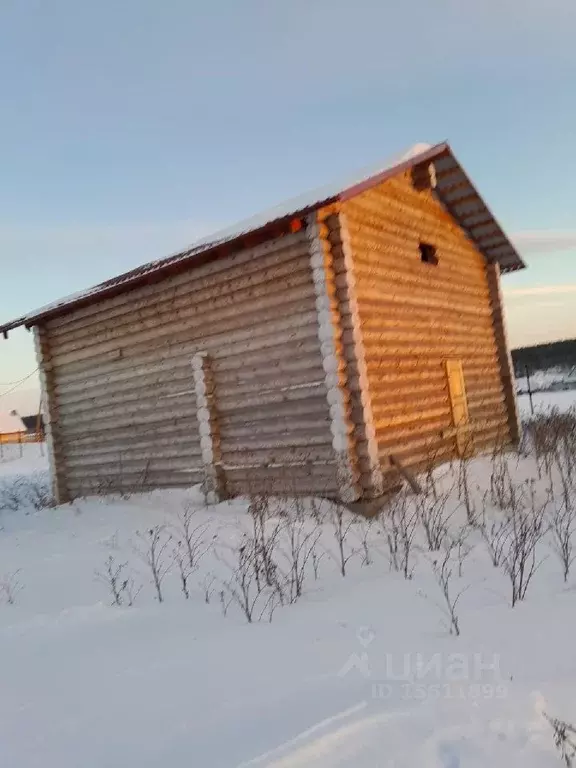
[0,0,576,408]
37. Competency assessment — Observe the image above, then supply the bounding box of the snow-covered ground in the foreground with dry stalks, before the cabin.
[0,424,576,768]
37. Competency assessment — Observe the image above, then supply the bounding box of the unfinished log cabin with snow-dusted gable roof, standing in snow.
[0,143,524,504]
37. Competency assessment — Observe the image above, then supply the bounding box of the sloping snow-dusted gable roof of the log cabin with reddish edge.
[0,143,525,337]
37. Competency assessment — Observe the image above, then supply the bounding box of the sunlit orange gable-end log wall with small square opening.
[341,174,510,469]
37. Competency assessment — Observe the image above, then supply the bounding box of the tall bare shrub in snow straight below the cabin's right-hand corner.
[501,482,549,607]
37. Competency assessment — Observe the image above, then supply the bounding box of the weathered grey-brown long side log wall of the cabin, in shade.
[41,230,338,499]
